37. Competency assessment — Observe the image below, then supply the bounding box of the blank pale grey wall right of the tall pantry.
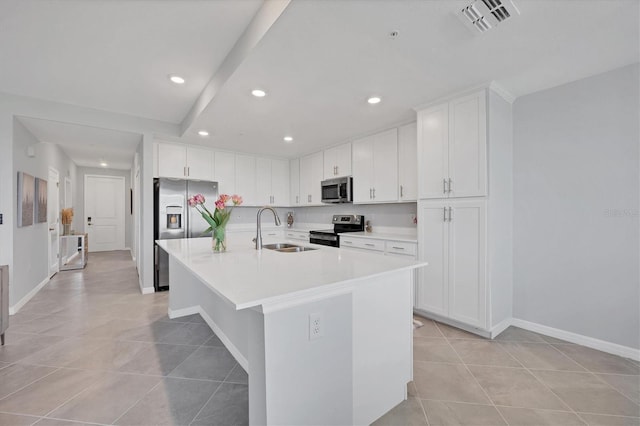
[513,64,640,348]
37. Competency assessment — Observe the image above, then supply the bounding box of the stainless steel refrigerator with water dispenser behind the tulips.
[153,178,218,291]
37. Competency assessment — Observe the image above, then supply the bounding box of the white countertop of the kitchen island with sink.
[157,238,427,310]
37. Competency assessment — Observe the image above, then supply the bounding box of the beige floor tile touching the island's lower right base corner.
[413,361,490,404]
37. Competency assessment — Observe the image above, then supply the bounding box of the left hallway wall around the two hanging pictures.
[9,119,77,306]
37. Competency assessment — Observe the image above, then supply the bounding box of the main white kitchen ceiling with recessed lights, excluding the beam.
[0,0,640,163]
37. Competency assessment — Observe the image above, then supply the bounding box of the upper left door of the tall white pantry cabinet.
[418,103,449,199]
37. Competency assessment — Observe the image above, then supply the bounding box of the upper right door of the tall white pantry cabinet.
[449,91,487,198]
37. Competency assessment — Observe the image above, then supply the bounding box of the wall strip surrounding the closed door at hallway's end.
[74,167,133,248]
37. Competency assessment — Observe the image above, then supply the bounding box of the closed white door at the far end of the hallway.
[84,175,125,252]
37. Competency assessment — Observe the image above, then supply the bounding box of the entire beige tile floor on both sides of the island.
[0,252,640,426]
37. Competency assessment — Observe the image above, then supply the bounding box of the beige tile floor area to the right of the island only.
[375,317,640,426]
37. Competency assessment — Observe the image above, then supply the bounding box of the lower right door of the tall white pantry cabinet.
[449,200,487,329]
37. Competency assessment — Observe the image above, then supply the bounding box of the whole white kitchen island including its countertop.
[158,238,426,425]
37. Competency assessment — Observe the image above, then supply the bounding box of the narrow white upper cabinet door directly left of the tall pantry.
[398,123,418,201]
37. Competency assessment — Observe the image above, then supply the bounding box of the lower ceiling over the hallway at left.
[18,117,142,170]
